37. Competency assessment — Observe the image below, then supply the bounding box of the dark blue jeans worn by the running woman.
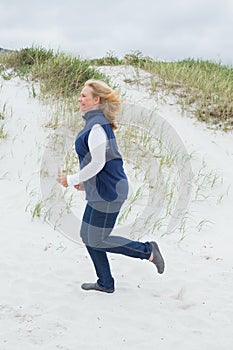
[80,201,152,288]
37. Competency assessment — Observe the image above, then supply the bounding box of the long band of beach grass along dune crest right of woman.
[91,51,233,131]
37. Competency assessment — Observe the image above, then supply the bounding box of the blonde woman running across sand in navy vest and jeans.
[57,80,164,293]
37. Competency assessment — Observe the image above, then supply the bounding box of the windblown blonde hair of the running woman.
[84,79,121,130]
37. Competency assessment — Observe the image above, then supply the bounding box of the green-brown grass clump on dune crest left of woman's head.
[0,47,108,98]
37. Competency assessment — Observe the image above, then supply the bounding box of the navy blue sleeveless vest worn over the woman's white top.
[75,109,128,202]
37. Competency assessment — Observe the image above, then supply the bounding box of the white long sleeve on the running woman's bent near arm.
[67,124,108,186]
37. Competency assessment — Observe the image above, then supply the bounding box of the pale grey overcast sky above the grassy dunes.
[0,0,233,65]
